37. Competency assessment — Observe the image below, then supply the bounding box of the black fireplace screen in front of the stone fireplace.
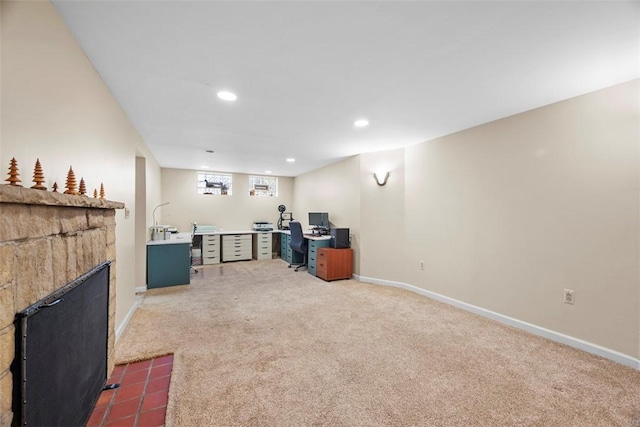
[13,261,111,426]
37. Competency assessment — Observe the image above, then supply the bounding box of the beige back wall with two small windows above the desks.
[160,168,293,231]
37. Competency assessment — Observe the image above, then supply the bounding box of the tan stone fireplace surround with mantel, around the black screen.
[0,185,124,426]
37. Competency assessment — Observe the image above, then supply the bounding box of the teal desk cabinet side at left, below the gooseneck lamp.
[147,243,191,289]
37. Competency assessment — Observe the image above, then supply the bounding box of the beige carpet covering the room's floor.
[116,260,640,427]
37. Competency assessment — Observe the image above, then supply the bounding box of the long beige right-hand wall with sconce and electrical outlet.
[295,80,640,358]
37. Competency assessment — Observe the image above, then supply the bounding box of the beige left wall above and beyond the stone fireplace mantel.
[0,1,159,332]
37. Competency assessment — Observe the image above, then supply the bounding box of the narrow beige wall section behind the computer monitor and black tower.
[293,156,360,274]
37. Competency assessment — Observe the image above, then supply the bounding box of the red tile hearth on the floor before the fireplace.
[87,354,173,427]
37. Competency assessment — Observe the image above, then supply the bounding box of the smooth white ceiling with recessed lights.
[53,0,640,176]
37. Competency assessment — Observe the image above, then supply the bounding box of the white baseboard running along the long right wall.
[353,274,640,370]
